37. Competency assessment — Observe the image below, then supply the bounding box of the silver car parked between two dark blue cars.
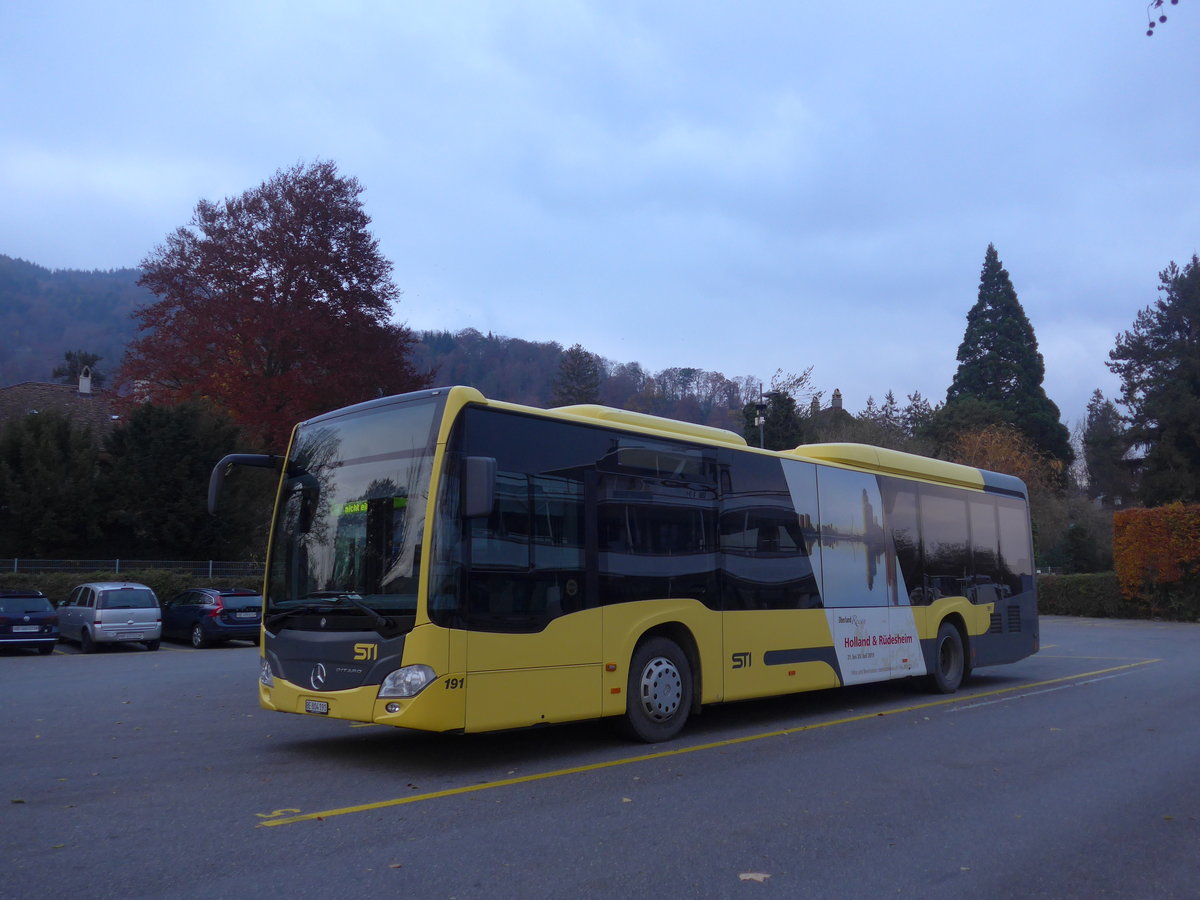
[59,581,162,653]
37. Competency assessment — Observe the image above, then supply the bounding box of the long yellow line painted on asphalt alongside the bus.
[258,659,1162,827]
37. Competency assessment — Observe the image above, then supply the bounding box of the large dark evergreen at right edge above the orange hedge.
[1108,256,1200,504]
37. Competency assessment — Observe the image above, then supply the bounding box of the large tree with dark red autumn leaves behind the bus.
[118,162,430,452]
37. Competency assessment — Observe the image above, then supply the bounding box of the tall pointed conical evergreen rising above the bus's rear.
[943,244,1075,469]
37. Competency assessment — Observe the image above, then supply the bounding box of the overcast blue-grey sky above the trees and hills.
[0,0,1200,426]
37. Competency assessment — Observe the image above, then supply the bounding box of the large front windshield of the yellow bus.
[266,395,442,614]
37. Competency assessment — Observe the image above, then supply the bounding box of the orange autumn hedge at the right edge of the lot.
[1112,503,1200,618]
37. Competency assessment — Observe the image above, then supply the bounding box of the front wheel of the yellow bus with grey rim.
[625,637,692,744]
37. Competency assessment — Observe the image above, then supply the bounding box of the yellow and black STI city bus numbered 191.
[209,386,1038,742]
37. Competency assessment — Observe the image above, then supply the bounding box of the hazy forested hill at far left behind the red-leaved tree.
[0,254,152,386]
